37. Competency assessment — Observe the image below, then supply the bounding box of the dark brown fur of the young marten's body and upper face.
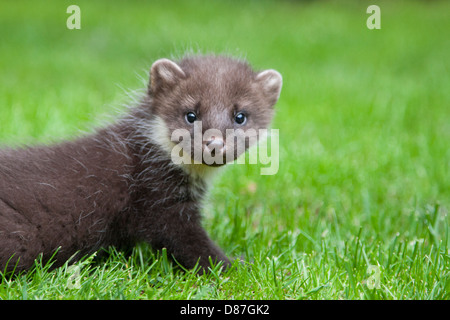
[0,57,281,271]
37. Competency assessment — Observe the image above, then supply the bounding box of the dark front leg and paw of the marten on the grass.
[146,203,231,271]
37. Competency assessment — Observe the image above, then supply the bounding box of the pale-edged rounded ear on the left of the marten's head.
[149,59,186,93]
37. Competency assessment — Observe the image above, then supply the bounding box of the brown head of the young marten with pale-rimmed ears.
[148,56,282,166]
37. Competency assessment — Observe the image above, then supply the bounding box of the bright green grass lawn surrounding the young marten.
[0,1,450,299]
